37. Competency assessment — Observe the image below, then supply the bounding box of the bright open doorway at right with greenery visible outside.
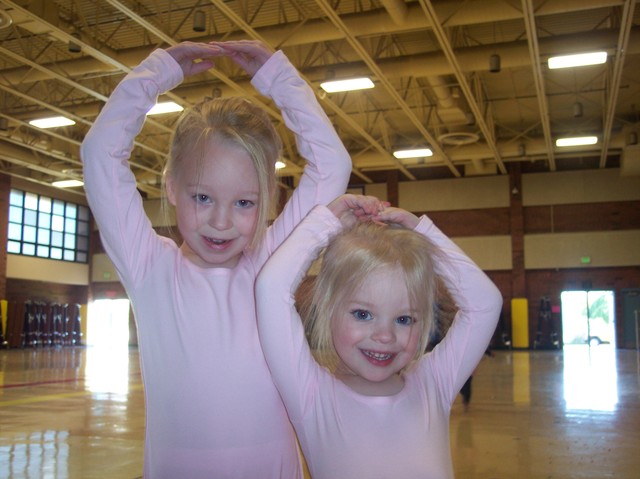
[560,291,616,349]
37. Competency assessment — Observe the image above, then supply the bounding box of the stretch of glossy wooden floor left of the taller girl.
[0,347,144,479]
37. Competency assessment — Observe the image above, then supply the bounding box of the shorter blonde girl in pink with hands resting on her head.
[256,195,502,479]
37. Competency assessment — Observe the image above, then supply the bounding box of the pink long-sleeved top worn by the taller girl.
[81,50,351,479]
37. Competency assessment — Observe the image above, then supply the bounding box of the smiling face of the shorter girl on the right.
[331,266,422,396]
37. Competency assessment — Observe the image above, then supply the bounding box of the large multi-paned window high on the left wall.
[7,189,89,263]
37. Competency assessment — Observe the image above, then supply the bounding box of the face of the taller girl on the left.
[167,142,260,268]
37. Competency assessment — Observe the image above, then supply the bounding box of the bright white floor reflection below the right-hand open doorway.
[563,344,618,412]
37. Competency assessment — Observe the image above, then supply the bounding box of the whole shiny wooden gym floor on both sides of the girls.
[0,345,640,479]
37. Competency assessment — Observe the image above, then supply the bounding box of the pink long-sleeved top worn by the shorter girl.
[256,206,502,479]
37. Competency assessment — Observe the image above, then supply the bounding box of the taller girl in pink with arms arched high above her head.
[81,41,351,479]
